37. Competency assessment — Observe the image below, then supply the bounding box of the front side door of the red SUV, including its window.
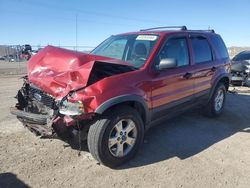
[151,35,194,120]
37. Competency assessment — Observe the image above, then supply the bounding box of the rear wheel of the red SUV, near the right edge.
[205,83,227,117]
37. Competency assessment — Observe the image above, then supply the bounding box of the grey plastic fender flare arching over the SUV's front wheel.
[95,94,150,124]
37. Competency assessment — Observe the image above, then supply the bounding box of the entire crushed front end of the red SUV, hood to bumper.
[10,46,135,140]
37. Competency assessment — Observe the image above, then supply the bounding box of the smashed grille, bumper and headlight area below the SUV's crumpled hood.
[10,76,94,139]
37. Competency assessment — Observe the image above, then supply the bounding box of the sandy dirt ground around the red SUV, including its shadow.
[0,72,250,188]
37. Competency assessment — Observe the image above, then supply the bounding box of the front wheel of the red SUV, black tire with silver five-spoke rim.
[88,106,144,168]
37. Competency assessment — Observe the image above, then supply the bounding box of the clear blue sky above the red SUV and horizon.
[0,0,250,49]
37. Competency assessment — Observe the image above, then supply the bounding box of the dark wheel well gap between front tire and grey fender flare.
[101,101,147,125]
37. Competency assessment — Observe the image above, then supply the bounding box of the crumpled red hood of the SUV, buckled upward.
[28,46,131,98]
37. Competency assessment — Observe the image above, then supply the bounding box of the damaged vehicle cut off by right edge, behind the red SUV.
[231,51,250,86]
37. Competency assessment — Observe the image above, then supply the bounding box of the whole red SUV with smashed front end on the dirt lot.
[11,26,230,167]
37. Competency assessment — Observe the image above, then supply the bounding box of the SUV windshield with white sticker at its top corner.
[91,34,159,68]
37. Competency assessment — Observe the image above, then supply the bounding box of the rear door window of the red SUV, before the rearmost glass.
[191,37,213,63]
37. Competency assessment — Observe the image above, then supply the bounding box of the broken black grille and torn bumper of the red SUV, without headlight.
[10,76,58,137]
